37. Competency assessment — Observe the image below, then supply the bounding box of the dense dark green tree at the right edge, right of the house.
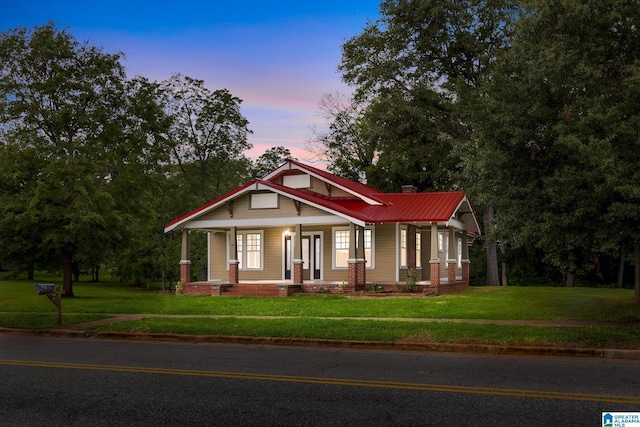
[471,0,640,285]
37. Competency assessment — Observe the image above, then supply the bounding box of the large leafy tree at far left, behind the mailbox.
[0,23,166,296]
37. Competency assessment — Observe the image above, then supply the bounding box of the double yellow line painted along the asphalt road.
[0,360,640,405]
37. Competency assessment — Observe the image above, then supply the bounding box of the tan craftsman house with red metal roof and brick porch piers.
[165,160,480,296]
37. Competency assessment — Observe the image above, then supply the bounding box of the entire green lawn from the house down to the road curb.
[0,276,640,348]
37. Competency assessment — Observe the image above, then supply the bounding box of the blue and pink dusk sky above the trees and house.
[0,0,379,159]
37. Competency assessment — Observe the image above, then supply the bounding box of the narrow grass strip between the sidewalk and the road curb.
[91,318,640,348]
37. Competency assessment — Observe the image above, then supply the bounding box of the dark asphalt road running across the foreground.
[0,335,640,427]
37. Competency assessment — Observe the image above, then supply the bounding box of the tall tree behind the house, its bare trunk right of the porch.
[339,0,519,284]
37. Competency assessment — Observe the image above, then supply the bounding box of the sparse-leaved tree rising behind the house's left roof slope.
[163,74,252,204]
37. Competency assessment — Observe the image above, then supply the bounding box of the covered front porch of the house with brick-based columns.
[180,223,469,297]
